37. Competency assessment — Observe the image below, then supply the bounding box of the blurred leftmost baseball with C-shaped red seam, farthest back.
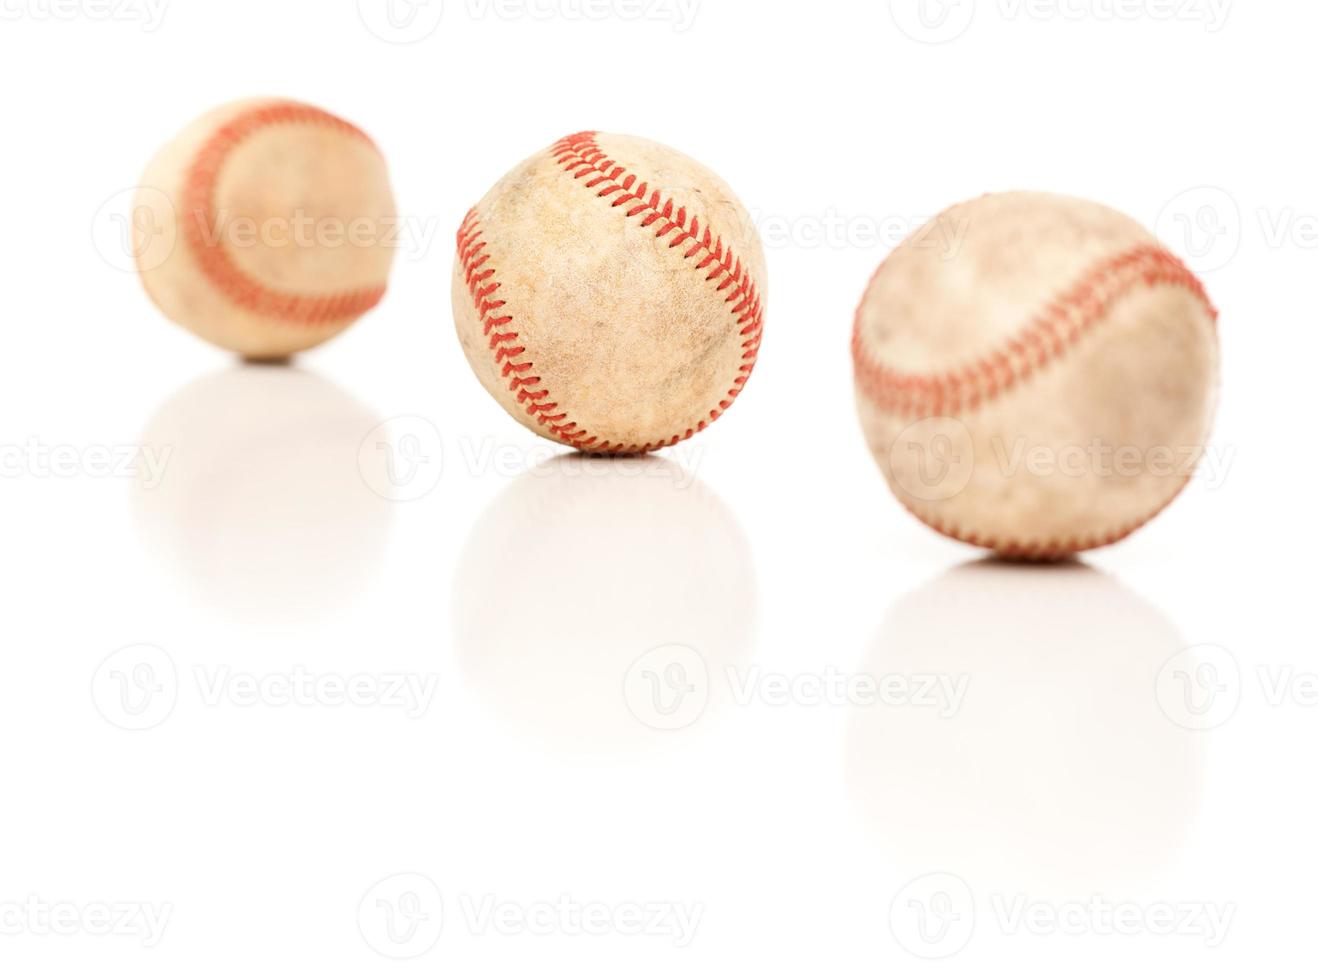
[133,99,395,358]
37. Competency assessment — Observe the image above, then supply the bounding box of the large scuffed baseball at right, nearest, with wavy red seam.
[853,194,1218,558]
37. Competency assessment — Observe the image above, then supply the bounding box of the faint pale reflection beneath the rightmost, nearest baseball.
[847,560,1202,893]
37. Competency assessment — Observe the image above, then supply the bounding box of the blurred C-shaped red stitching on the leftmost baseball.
[183,103,385,325]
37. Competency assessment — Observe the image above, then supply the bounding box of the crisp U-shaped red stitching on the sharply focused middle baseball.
[457,132,764,454]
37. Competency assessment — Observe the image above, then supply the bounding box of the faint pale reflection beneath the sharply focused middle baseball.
[453,454,757,756]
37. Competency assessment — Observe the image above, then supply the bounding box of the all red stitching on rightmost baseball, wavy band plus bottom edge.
[851,245,1218,560]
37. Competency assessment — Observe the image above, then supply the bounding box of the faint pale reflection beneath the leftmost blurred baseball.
[133,364,391,623]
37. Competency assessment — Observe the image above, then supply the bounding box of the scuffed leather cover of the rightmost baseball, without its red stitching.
[857,194,1218,552]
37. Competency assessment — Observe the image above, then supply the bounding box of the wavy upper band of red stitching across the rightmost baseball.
[851,245,1218,419]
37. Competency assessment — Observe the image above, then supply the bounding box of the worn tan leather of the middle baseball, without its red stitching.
[453,134,764,447]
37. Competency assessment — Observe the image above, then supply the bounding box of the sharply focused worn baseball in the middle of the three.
[453,133,764,453]
